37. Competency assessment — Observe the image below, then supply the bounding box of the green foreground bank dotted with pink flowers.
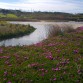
[0,29,83,83]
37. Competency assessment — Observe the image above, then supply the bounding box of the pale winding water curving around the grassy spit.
[0,22,83,46]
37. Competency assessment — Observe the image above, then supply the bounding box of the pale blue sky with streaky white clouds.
[0,0,83,13]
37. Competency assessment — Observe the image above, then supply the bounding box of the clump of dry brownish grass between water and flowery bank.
[46,24,75,36]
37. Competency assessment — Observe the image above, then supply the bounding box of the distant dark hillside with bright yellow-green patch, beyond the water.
[0,9,83,21]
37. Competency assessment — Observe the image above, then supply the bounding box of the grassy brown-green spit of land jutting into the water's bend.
[0,21,35,40]
